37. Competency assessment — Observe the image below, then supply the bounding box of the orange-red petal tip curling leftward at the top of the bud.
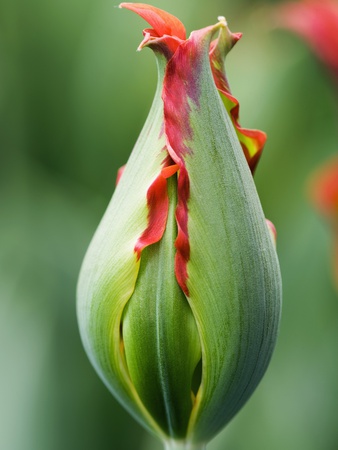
[120,3,186,40]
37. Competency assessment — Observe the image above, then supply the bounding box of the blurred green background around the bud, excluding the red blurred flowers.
[0,0,338,450]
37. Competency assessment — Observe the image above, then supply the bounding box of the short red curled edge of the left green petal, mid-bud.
[134,174,169,259]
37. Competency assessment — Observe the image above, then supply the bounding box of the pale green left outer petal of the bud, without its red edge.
[77,55,167,433]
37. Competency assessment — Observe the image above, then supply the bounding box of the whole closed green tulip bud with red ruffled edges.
[78,3,281,449]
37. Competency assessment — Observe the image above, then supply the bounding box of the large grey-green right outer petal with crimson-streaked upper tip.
[160,19,281,442]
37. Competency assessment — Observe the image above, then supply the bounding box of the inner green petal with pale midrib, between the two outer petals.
[123,175,201,438]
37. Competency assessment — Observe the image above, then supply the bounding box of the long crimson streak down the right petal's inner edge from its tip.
[162,27,211,296]
